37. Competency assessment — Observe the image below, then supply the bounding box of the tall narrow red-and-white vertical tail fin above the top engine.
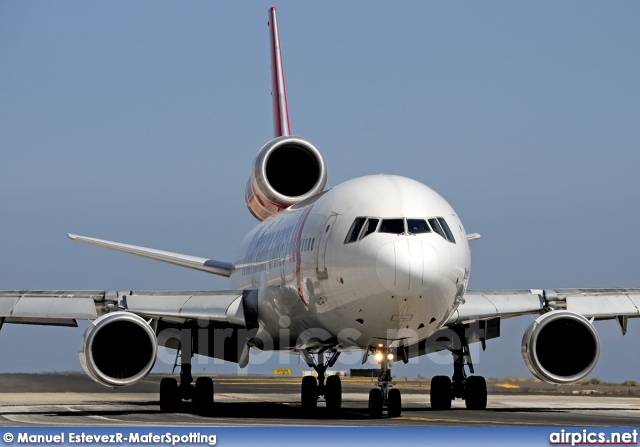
[268,6,291,138]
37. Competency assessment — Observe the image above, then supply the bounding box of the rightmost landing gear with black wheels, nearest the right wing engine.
[430,344,487,410]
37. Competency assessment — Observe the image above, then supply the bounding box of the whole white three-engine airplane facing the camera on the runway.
[0,7,640,417]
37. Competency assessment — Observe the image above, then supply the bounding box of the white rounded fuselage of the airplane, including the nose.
[231,175,470,352]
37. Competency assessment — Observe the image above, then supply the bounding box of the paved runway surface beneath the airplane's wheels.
[0,374,640,427]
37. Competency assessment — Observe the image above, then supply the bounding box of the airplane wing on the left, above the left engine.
[0,290,257,327]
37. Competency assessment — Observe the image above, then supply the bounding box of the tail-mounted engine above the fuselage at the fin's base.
[245,136,327,221]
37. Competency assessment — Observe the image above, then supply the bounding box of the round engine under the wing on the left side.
[80,312,158,388]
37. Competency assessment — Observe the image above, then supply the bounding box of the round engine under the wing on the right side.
[522,310,600,385]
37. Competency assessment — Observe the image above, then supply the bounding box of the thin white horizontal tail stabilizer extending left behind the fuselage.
[68,234,234,277]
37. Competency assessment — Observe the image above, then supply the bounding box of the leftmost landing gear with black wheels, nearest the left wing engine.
[160,330,213,414]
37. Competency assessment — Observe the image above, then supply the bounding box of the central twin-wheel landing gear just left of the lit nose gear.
[300,351,342,412]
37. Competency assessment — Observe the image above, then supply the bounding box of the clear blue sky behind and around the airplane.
[0,1,640,380]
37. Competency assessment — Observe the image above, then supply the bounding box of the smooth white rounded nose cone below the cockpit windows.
[376,239,439,296]
